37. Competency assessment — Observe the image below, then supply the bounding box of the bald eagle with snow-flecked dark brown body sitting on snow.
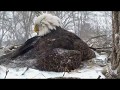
[0,13,95,72]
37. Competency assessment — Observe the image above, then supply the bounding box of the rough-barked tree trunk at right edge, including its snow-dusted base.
[104,11,120,79]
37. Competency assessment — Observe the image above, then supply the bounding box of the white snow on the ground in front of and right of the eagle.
[0,49,107,79]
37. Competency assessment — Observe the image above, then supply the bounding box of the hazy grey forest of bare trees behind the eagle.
[0,11,112,48]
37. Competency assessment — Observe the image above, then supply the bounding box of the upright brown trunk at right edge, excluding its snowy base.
[111,11,120,70]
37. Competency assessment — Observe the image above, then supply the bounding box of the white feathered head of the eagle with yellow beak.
[34,13,61,36]
